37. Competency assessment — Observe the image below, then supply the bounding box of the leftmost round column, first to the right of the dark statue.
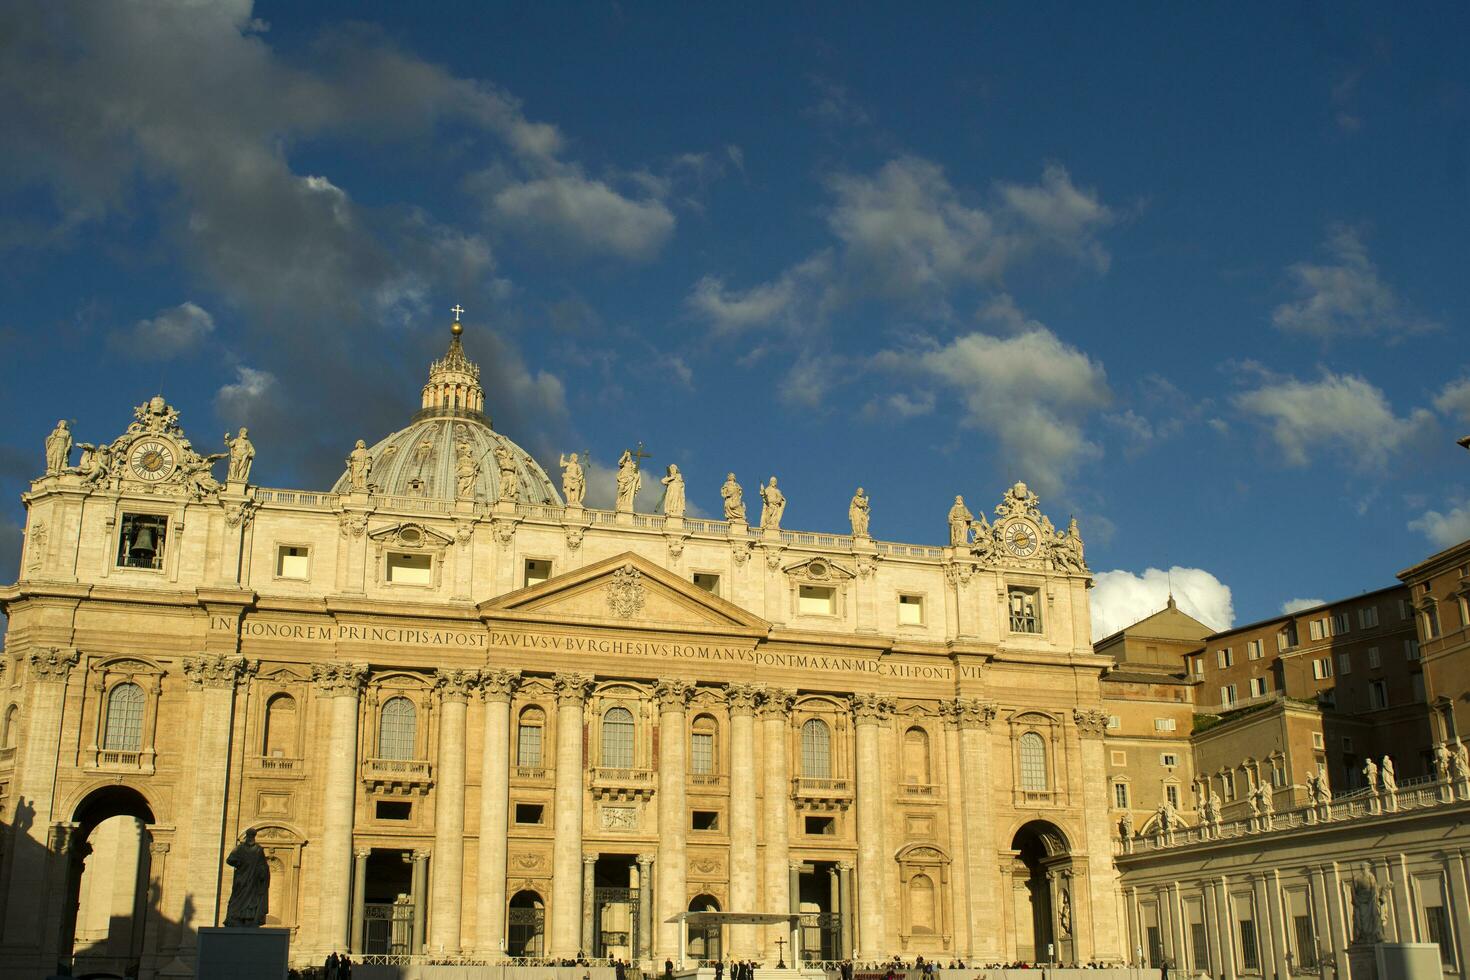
[312,664,368,955]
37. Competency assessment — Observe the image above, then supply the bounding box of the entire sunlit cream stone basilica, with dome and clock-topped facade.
[0,321,1126,976]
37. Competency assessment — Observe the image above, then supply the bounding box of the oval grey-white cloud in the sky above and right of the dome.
[488,167,675,260]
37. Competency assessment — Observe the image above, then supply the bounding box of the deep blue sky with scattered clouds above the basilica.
[0,0,1470,635]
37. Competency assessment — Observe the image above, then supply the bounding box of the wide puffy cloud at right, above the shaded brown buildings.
[1232,372,1433,469]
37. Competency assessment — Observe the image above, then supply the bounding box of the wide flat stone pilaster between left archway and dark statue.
[184,655,248,945]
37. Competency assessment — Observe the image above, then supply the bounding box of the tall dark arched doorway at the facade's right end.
[1010,820,1076,962]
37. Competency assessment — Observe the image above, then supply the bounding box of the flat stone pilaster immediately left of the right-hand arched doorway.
[956,698,999,959]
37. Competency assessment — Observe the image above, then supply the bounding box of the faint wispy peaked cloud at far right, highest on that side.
[1272,225,1435,339]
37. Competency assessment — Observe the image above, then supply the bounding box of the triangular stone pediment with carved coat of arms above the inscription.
[479,551,770,636]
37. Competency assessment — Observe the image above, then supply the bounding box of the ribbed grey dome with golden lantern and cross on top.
[332,322,562,504]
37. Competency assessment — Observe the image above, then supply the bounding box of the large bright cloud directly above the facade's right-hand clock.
[873,314,1111,494]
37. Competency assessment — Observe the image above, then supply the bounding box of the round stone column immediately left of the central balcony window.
[547,673,592,958]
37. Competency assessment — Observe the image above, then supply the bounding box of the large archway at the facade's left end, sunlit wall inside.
[57,786,163,974]
